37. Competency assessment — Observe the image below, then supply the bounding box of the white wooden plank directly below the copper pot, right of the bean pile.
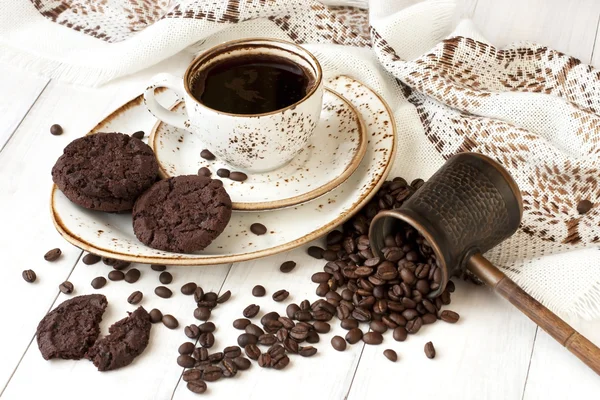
[348,281,536,400]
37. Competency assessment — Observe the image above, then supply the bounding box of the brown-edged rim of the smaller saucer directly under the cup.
[148,85,368,211]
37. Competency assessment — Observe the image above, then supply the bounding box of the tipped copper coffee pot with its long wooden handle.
[369,153,600,375]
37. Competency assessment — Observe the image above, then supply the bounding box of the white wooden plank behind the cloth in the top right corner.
[473,0,600,63]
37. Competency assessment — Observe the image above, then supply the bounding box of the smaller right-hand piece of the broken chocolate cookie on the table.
[86,307,152,371]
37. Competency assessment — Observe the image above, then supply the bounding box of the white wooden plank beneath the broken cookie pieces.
[2,261,230,400]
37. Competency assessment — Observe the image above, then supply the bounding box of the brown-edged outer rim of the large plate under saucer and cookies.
[50,75,398,266]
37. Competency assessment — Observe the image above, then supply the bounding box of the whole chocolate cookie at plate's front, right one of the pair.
[133,175,231,253]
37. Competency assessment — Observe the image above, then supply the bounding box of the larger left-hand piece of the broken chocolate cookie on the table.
[36,294,108,360]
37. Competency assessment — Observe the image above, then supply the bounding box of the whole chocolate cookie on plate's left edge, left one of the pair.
[52,133,158,212]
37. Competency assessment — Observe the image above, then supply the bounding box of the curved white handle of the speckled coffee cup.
[144,73,190,130]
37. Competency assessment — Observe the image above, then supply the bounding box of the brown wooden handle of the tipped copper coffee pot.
[467,254,600,375]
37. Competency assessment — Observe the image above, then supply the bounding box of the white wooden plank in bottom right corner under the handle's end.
[523,318,600,400]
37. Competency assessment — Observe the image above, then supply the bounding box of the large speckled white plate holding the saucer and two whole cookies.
[51,76,396,265]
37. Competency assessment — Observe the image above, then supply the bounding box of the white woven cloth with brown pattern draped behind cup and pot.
[0,0,600,318]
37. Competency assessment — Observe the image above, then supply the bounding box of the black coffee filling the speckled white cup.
[191,54,314,115]
